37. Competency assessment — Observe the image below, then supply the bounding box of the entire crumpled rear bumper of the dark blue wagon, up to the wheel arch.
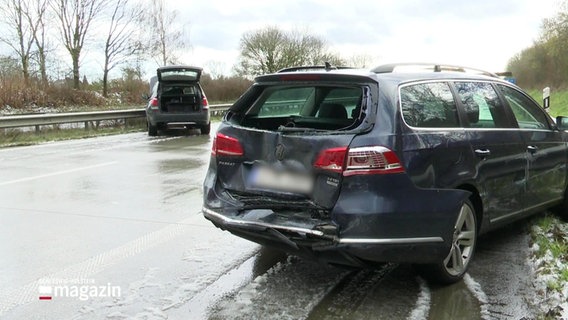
[203,169,470,267]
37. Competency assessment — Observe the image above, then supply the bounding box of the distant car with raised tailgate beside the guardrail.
[146,66,211,136]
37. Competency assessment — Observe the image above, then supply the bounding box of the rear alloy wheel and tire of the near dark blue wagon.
[414,200,477,284]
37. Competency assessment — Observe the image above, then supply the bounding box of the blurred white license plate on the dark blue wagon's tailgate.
[251,167,314,194]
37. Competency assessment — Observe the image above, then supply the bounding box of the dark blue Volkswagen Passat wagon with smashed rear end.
[203,65,568,283]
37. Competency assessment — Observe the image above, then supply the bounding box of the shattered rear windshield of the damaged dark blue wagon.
[234,85,364,131]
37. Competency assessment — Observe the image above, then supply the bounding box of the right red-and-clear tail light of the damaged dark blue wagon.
[314,146,404,177]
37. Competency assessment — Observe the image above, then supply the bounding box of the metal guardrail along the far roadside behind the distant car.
[0,104,231,129]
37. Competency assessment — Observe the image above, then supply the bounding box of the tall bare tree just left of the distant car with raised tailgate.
[103,0,144,97]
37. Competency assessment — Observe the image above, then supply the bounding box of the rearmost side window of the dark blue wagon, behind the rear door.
[400,82,459,128]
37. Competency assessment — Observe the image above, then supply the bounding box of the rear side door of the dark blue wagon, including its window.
[454,81,527,222]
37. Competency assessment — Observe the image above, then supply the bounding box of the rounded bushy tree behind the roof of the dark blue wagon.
[235,27,344,77]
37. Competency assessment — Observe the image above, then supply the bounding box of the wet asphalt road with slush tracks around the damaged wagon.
[0,133,535,319]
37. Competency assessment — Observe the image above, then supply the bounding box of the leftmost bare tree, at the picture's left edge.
[0,0,34,83]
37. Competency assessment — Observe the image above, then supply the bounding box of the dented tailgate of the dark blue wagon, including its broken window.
[215,82,371,210]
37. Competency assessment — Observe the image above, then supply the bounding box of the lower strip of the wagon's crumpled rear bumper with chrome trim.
[203,207,449,267]
